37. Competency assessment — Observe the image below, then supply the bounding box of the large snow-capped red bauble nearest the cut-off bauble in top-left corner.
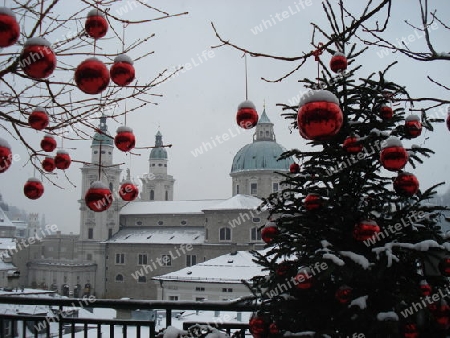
[19,37,56,79]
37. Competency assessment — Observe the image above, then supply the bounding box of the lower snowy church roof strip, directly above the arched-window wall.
[105,227,205,244]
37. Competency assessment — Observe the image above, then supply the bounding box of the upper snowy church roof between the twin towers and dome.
[120,199,224,215]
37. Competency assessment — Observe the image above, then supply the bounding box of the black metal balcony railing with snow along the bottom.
[0,295,255,338]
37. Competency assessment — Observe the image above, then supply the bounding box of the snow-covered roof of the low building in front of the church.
[152,251,262,284]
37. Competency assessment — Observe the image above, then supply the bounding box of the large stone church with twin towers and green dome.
[17,110,293,300]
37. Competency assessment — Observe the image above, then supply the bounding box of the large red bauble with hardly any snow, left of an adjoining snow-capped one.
[75,57,109,94]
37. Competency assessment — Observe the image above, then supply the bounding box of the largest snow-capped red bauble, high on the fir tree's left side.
[297,90,343,141]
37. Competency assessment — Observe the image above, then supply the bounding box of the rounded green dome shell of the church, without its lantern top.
[231,141,294,173]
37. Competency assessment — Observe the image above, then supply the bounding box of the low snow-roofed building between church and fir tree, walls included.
[152,251,262,301]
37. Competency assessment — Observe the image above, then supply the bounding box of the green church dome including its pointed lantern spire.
[231,109,294,174]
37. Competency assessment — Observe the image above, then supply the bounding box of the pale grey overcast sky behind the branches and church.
[0,0,450,233]
